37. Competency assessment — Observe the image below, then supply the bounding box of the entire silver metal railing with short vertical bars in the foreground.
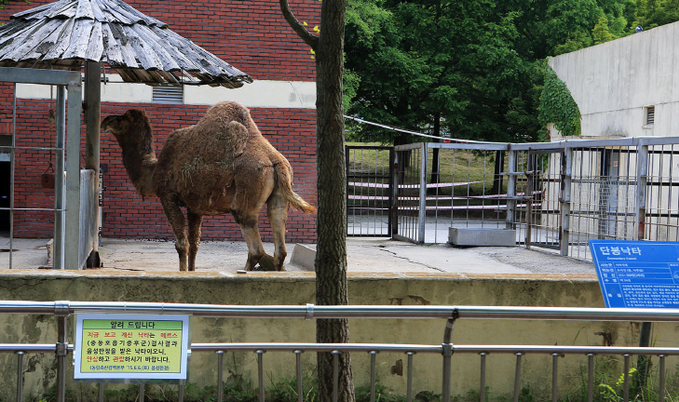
[0,301,679,402]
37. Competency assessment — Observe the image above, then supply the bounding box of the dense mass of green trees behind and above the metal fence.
[344,0,679,144]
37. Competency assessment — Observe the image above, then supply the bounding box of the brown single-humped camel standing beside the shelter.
[101,102,316,271]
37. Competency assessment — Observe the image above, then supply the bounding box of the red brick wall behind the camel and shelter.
[0,0,320,242]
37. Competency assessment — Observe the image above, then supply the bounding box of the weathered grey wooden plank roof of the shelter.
[0,0,252,88]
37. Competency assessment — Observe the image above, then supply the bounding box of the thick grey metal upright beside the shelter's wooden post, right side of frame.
[64,85,82,269]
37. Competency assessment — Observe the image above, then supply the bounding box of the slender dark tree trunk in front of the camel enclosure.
[280,0,355,402]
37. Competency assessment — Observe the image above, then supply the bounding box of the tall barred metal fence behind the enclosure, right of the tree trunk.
[347,137,679,260]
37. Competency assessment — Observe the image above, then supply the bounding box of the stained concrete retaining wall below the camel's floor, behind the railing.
[0,269,677,400]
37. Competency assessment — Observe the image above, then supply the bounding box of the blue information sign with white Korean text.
[589,240,679,308]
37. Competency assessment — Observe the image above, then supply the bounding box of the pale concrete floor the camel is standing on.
[0,238,596,276]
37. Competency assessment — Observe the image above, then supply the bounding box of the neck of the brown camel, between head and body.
[121,129,158,197]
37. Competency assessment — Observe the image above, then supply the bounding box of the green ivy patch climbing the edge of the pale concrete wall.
[539,66,580,136]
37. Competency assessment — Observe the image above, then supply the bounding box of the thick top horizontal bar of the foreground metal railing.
[0,301,679,322]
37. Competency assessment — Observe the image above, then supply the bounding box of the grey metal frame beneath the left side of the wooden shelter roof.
[0,67,82,269]
